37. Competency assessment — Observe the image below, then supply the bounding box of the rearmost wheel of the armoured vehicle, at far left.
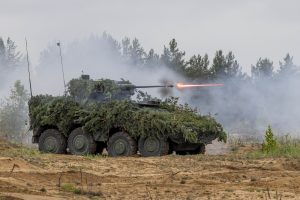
[39,129,67,154]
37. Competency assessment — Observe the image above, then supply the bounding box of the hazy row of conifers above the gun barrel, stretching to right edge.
[91,33,300,82]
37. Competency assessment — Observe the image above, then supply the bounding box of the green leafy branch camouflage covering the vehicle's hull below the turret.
[29,96,226,142]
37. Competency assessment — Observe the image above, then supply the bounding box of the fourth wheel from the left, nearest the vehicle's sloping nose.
[139,136,169,157]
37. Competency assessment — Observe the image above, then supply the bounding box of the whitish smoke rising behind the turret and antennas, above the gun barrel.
[32,36,181,96]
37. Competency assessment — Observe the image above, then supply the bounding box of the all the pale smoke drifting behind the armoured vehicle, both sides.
[0,36,300,139]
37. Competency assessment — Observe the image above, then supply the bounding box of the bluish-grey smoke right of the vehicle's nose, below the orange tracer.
[186,76,300,137]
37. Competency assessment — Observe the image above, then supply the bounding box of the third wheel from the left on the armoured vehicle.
[107,132,137,157]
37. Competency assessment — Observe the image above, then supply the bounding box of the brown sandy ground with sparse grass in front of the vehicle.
[0,142,300,200]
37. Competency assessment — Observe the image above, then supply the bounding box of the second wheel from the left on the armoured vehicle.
[68,127,97,155]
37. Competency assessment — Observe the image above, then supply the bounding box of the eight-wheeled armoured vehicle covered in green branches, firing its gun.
[29,75,226,156]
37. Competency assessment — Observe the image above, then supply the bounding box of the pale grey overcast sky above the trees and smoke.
[0,0,300,71]
